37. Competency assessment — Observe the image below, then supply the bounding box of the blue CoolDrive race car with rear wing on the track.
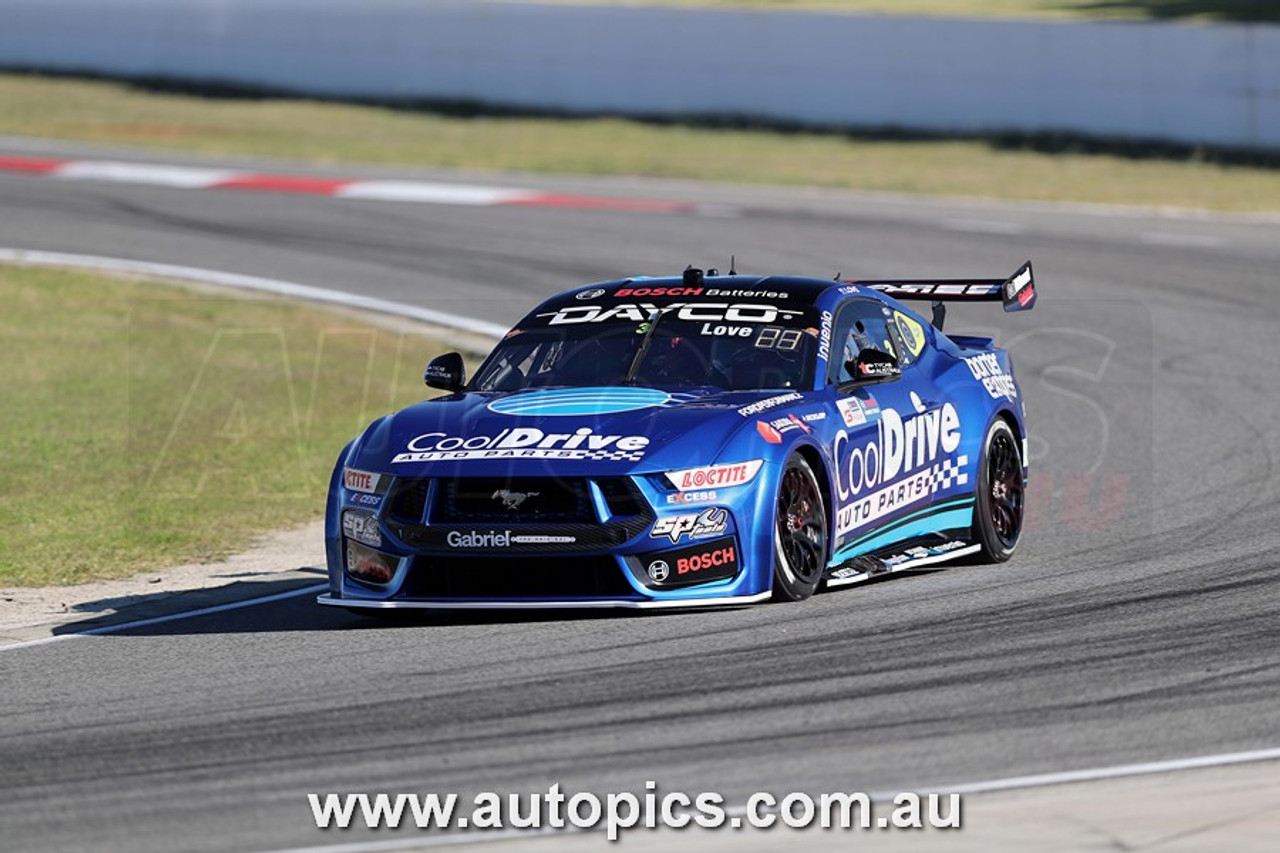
[319,261,1037,613]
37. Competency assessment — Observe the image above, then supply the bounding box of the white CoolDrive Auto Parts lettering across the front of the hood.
[392,427,649,462]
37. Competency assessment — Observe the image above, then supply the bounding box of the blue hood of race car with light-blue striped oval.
[348,387,801,476]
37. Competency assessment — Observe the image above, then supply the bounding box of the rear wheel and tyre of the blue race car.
[973,419,1025,562]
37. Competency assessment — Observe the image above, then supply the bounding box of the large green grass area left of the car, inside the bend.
[0,268,458,587]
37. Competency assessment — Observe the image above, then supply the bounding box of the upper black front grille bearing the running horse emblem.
[431,476,588,524]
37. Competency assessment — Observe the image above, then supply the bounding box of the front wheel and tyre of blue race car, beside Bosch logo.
[773,456,827,601]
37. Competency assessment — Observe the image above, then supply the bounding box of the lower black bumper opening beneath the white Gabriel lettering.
[403,555,635,599]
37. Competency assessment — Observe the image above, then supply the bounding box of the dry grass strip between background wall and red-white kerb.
[0,74,1280,211]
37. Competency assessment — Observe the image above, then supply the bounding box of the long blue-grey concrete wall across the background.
[0,0,1280,149]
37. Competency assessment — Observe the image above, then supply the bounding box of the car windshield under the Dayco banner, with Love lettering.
[470,304,818,391]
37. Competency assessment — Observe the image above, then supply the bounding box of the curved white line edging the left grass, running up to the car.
[0,248,507,338]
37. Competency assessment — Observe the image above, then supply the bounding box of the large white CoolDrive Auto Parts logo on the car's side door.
[833,403,968,535]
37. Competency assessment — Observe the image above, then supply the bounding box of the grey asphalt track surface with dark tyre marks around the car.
[0,142,1280,852]
